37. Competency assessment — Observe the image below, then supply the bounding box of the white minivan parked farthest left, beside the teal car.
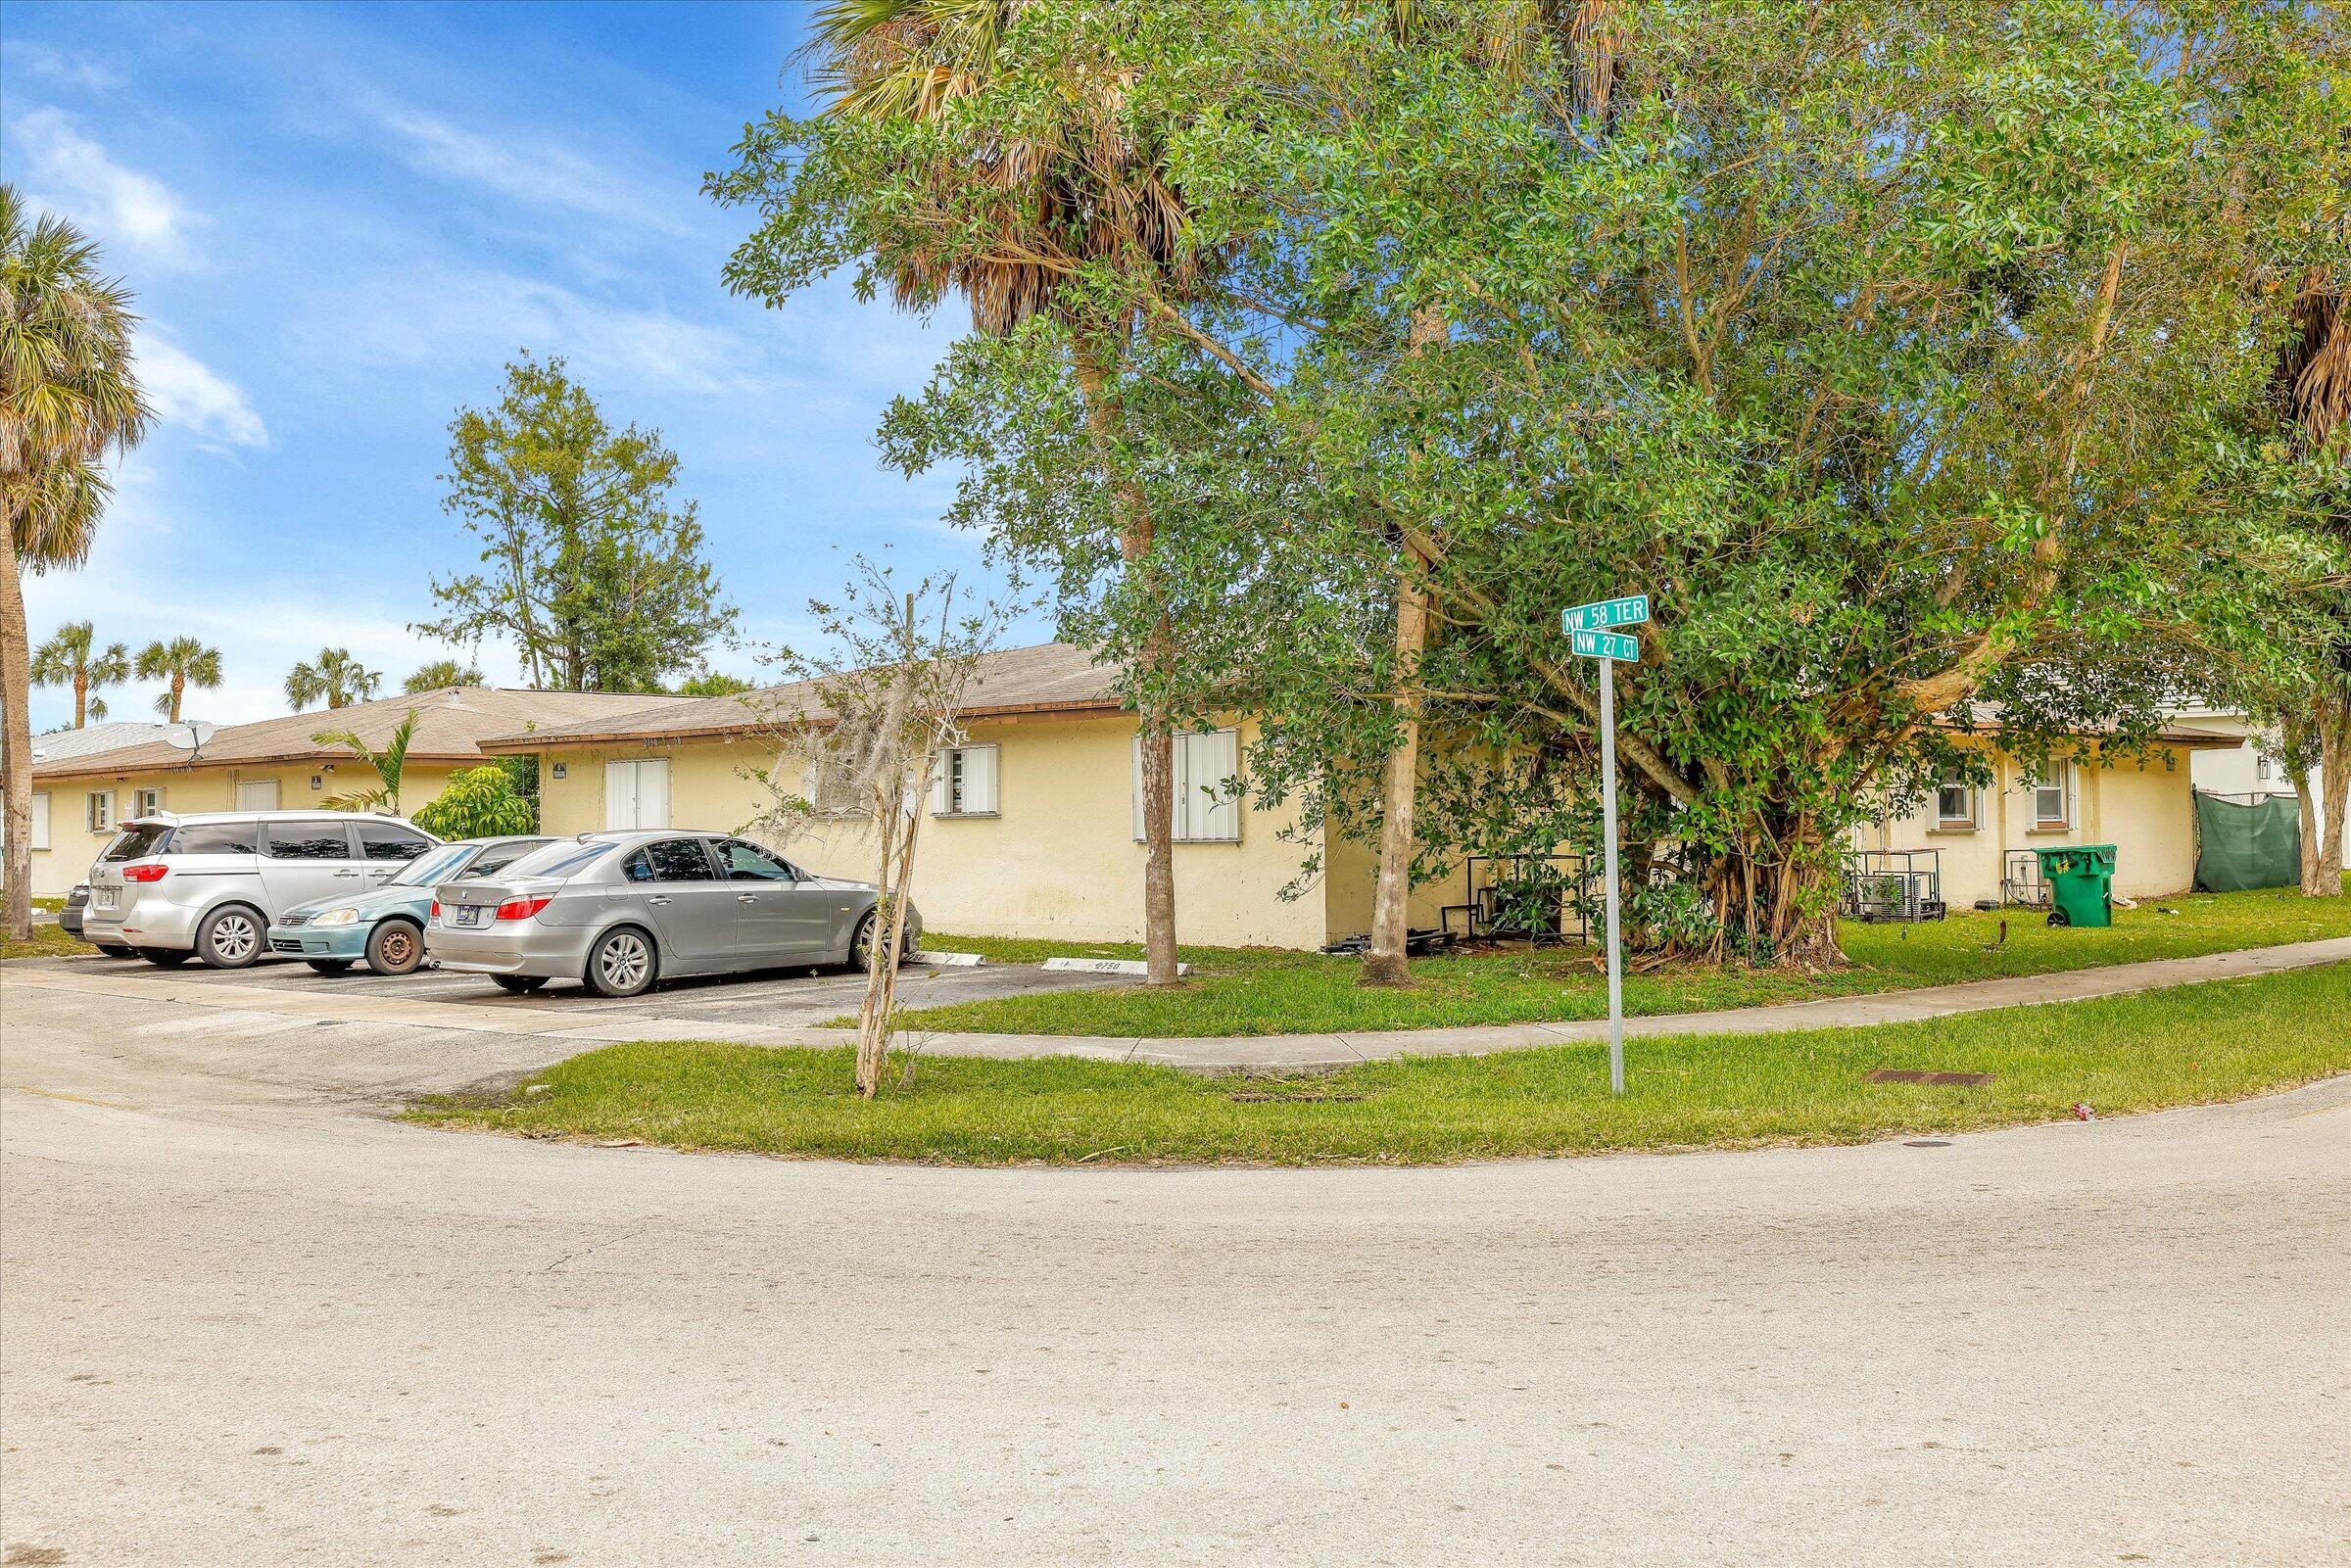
[82,811,440,969]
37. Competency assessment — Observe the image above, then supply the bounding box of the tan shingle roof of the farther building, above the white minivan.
[33,687,698,778]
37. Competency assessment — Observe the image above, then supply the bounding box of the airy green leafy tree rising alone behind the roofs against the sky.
[416,355,736,691]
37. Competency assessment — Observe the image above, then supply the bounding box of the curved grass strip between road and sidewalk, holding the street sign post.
[409,967,2351,1166]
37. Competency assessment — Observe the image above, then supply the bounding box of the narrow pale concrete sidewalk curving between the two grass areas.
[0,938,2351,1072]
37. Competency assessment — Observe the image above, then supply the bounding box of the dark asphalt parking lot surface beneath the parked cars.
[17,955,1122,1027]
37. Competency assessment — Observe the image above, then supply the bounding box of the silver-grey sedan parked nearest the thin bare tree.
[425,828,922,997]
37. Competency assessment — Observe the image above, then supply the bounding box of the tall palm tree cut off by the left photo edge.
[0,183,148,938]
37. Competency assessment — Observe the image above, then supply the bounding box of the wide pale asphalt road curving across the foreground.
[0,982,2351,1568]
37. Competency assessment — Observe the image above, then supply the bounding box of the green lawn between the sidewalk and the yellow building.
[884,888,2351,1037]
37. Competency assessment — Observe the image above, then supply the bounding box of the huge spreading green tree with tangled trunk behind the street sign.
[818,0,2346,964]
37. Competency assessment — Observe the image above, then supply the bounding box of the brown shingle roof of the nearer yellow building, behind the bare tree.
[482,641,1119,752]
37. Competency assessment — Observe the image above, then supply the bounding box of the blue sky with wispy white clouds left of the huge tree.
[0,0,1025,729]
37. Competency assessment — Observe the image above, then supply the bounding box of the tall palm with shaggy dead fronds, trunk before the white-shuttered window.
[809,0,1204,985]
